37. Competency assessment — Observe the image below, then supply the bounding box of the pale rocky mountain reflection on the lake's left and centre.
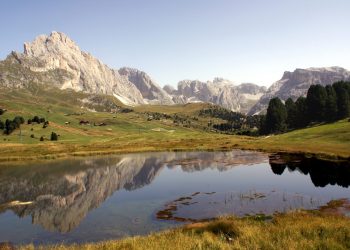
[0,151,266,232]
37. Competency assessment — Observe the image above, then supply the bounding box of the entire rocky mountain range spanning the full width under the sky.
[0,31,350,114]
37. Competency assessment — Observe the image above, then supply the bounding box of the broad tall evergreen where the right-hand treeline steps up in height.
[306,84,327,121]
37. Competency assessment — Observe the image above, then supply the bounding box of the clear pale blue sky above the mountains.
[0,0,350,86]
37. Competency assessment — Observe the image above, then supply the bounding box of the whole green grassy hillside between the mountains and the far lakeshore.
[0,84,350,160]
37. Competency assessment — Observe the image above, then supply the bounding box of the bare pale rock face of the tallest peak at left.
[1,31,145,105]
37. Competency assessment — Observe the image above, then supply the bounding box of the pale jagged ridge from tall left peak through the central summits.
[0,31,266,111]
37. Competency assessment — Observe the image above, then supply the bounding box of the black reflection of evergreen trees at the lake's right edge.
[270,155,350,188]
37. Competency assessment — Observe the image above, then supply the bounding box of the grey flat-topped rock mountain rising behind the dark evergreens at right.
[248,67,350,115]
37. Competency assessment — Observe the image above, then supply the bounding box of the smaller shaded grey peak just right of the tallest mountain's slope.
[118,67,174,105]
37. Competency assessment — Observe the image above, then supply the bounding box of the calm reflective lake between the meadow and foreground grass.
[0,150,350,244]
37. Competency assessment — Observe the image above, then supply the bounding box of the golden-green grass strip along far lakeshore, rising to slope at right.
[0,120,350,162]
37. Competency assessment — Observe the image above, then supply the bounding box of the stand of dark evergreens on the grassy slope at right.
[260,81,350,134]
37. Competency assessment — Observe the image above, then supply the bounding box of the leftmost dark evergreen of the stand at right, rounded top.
[265,97,287,133]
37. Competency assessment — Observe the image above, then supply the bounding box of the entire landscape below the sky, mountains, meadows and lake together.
[0,26,350,249]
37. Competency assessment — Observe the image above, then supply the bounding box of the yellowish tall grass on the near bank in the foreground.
[20,212,350,250]
